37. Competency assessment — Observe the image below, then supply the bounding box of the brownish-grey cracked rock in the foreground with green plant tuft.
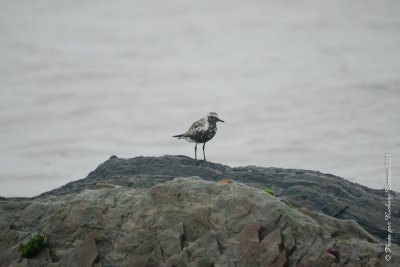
[0,177,400,267]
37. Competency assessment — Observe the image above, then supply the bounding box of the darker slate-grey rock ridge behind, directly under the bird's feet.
[34,156,400,247]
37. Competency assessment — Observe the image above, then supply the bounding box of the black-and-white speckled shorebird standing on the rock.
[173,112,225,161]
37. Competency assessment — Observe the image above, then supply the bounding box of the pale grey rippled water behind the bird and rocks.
[0,0,400,196]
